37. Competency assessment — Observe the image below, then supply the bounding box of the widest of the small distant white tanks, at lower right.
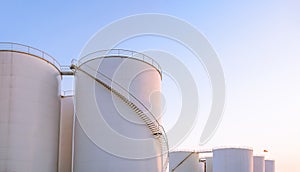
[213,148,253,172]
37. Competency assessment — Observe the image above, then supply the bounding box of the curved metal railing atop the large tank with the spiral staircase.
[78,49,162,75]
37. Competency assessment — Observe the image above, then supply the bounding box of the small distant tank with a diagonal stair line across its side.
[169,151,200,172]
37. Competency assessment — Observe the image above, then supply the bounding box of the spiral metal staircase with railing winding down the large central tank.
[73,65,169,171]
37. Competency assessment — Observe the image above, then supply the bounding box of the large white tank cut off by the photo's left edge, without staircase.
[0,44,61,172]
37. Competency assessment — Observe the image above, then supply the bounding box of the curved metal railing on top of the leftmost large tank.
[0,42,61,70]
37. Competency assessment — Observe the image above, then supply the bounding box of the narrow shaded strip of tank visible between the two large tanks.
[58,96,74,172]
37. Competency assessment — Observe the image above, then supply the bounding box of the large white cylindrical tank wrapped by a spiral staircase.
[74,53,162,172]
